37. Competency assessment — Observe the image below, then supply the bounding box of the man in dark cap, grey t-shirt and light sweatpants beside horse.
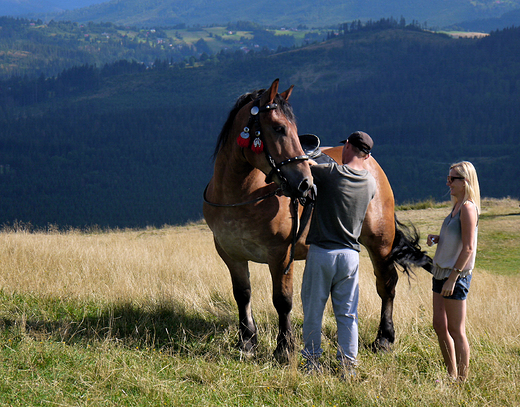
[301,131,376,374]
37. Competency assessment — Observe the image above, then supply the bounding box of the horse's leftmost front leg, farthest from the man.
[215,242,258,355]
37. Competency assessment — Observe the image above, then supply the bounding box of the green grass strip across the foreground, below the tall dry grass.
[0,294,520,407]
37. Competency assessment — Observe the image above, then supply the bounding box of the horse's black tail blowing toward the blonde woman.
[388,216,433,276]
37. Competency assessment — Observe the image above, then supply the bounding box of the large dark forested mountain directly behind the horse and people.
[0,20,520,227]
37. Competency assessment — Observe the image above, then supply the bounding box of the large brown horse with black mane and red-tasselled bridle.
[203,79,431,360]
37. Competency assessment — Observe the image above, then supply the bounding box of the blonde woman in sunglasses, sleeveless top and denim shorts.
[427,161,480,381]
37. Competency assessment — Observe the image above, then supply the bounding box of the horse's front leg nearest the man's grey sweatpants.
[269,262,294,363]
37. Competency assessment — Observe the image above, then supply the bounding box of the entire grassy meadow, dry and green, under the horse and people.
[0,199,520,406]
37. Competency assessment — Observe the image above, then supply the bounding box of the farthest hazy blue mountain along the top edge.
[42,0,520,28]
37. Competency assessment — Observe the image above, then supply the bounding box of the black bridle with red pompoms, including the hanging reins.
[203,98,316,274]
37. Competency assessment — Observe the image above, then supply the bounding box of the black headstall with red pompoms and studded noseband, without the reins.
[237,98,310,185]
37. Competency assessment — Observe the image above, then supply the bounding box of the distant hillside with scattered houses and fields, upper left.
[0,17,328,79]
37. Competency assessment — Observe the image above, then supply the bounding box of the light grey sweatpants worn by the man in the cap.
[301,245,359,363]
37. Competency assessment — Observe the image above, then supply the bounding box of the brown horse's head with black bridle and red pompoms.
[230,79,313,198]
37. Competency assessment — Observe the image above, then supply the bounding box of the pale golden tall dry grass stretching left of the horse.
[0,226,229,307]
